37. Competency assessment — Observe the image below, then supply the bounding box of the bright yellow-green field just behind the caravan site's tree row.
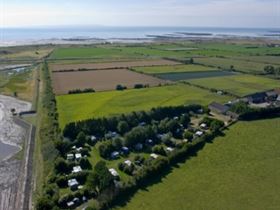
[56,84,230,128]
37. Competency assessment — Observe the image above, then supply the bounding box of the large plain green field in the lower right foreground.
[112,118,280,210]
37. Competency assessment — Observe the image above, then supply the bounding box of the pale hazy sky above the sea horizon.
[0,0,280,28]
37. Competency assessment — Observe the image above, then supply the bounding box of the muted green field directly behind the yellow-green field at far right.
[194,57,278,73]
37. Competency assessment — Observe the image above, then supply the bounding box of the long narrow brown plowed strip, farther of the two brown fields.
[50,59,181,71]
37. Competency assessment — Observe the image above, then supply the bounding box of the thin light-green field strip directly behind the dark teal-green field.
[133,64,217,74]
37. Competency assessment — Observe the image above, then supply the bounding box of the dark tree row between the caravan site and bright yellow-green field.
[63,105,203,140]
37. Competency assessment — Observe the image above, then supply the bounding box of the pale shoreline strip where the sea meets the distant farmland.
[0,32,280,48]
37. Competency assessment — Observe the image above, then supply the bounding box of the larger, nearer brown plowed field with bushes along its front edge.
[52,69,168,95]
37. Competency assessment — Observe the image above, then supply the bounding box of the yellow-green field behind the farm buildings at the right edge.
[188,75,280,96]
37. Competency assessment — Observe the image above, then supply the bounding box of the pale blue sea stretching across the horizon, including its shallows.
[0,26,280,46]
